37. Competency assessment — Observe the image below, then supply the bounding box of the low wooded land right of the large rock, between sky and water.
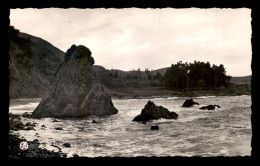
[93,62,251,98]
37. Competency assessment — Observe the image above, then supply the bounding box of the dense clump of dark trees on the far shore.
[163,61,231,90]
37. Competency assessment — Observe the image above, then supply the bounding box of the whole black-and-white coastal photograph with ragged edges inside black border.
[8,7,252,158]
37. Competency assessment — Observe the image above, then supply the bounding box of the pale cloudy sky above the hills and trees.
[10,8,252,76]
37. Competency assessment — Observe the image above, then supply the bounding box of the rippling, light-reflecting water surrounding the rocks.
[10,96,252,157]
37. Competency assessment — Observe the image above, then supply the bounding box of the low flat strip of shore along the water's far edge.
[9,85,251,101]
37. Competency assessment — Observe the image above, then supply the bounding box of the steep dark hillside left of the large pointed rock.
[9,26,65,98]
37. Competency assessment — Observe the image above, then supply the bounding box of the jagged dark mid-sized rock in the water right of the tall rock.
[133,101,178,122]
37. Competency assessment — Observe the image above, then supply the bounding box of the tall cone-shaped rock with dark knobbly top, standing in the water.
[32,45,118,118]
